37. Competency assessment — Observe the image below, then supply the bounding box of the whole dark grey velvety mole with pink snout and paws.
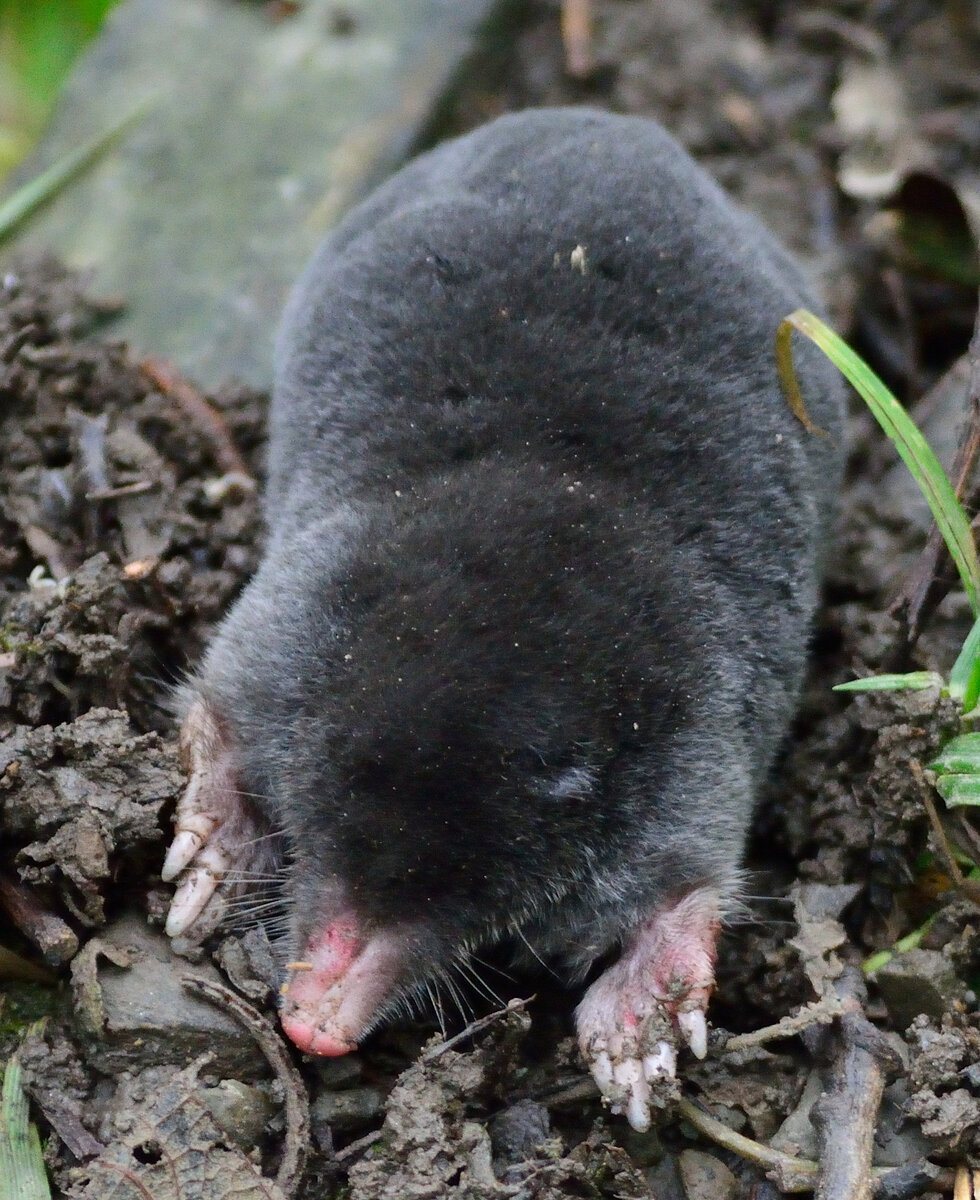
[167,110,840,1126]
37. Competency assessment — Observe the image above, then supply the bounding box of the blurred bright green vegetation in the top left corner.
[0,0,119,178]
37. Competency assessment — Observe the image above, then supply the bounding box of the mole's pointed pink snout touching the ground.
[282,914,407,1057]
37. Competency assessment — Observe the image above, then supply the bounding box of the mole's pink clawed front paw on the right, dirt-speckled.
[576,888,721,1130]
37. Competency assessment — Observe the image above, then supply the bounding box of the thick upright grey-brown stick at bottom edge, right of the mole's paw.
[810,967,895,1200]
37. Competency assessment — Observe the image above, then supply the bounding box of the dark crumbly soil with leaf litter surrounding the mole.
[0,0,980,1200]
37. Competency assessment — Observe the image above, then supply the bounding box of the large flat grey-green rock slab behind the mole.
[7,0,495,386]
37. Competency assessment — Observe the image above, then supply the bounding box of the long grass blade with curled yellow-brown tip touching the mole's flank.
[776,308,980,617]
